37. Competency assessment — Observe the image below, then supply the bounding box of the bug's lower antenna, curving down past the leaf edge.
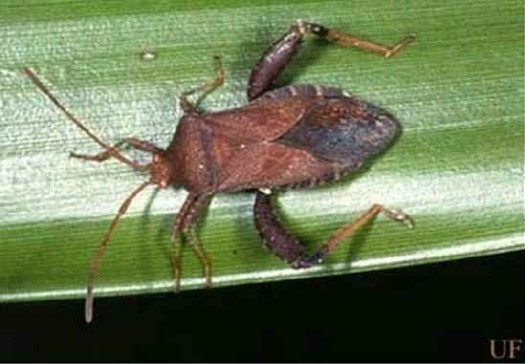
[84,181,151,323]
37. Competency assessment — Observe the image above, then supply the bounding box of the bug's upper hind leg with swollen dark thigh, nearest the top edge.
[247,20,415,100]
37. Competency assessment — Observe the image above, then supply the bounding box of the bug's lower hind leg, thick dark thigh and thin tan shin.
[254,192,413,269]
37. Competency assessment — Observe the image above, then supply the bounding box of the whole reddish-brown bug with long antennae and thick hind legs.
[23,21,415,322]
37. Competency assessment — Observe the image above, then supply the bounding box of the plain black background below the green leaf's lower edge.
[0,252,525,362]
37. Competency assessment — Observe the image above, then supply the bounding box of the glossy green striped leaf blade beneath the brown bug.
[0,0,525,301]
